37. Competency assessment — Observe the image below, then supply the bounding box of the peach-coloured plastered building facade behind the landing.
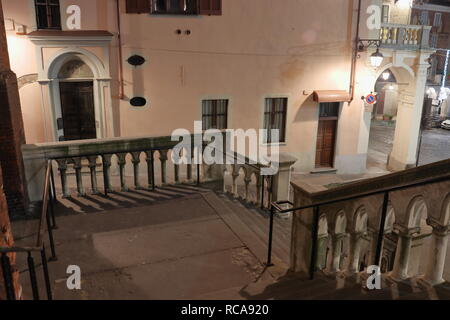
[4,0,432,180]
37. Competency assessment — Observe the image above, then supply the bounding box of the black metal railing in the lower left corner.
[0,161,57,300]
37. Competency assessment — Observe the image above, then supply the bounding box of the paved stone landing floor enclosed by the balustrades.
[13,186,287,300]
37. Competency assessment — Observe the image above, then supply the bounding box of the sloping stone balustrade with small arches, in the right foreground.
[291,159,450,285]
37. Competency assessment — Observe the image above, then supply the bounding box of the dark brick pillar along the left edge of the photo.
[0,2,28,215]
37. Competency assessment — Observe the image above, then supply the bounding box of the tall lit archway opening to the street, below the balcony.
[367,64,420,172]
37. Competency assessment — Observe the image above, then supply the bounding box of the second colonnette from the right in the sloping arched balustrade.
[390,226,418,280]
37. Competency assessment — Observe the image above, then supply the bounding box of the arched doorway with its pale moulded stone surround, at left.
[44,48,113,141]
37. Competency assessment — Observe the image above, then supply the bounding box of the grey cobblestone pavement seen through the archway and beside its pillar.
[367,121,450,170]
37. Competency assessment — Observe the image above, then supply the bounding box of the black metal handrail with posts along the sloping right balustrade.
[266,173,450,280]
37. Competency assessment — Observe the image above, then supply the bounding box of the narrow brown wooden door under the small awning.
[316,120,337,168]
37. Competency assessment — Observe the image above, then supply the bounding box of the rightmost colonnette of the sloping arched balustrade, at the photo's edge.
[423,219,449,286]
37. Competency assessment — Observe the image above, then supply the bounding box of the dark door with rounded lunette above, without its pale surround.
[57,56,97,141]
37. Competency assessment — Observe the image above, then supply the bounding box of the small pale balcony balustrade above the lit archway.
[380,23,431,49]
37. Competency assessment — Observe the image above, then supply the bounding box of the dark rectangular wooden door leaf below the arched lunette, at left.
[59,81,97,140]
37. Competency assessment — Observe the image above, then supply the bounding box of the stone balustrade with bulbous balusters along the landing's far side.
[23,135,296,207]
